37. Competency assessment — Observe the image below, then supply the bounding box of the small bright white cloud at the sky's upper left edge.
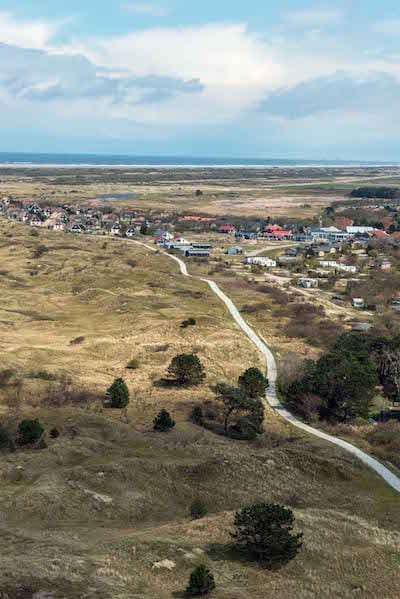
[0,12,62,48]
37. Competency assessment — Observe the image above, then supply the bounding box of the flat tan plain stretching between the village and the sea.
[0,167,400,219]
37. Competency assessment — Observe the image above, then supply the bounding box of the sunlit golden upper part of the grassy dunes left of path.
[0,221,262,426]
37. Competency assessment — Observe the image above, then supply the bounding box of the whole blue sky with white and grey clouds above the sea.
[0,0,400,161]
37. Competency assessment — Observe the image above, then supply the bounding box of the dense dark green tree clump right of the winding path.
[282,332,400,422]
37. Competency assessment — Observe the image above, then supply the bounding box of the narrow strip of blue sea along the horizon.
[0,152,400,168]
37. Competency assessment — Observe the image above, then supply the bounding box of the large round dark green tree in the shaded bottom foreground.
[231,503,303,566]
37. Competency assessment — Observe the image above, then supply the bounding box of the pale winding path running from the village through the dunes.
[134,241,400,493]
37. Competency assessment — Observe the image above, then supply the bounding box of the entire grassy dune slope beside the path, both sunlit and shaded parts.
[0,221,400,599]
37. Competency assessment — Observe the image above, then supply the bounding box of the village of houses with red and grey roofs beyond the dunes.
[0,196,400,312]
